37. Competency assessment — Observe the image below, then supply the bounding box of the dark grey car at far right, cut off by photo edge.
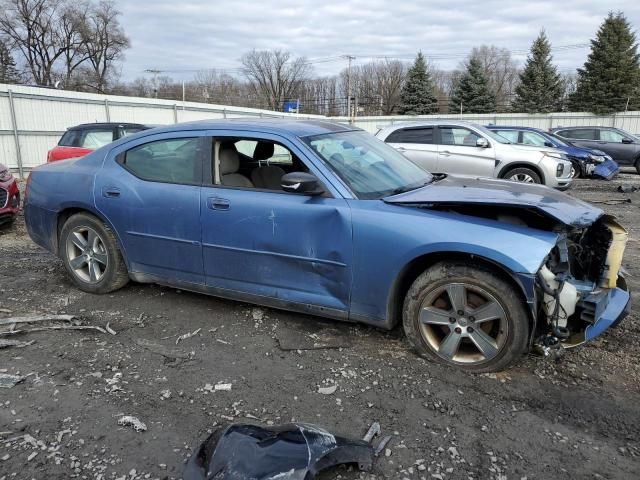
[551,127,640,173]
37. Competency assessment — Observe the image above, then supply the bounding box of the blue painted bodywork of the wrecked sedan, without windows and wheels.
[24,120,629,348]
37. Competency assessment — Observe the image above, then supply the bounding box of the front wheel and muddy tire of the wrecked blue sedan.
[402,262,530,373]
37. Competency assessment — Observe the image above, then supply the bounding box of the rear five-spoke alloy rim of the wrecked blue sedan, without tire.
[66,226,109,283]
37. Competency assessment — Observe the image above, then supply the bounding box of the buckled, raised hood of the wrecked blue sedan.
[384,176,604,227]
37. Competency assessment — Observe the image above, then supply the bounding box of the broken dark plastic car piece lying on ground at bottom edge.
[182,423,373,480]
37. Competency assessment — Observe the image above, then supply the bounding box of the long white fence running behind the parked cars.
[0,84,640,176]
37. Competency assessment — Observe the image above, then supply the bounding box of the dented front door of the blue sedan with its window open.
[200,134,352,315]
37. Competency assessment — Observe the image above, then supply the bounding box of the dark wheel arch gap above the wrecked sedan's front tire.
[387,251,535,332]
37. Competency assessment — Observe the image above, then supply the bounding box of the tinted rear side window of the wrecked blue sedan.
[120,138,200,185]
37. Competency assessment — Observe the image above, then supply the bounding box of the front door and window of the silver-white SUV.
[435,125,496,177]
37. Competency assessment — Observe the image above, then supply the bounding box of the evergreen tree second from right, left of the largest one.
[511,30,564,113]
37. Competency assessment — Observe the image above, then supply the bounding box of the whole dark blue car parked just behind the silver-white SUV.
[487,125,620,180]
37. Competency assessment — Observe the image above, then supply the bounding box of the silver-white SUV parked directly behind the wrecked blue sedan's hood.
[376,120,572,190]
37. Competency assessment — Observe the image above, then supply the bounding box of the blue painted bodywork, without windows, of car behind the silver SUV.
[487,125,620,180]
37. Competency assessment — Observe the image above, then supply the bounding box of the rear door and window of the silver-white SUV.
[385,126,438,172]
